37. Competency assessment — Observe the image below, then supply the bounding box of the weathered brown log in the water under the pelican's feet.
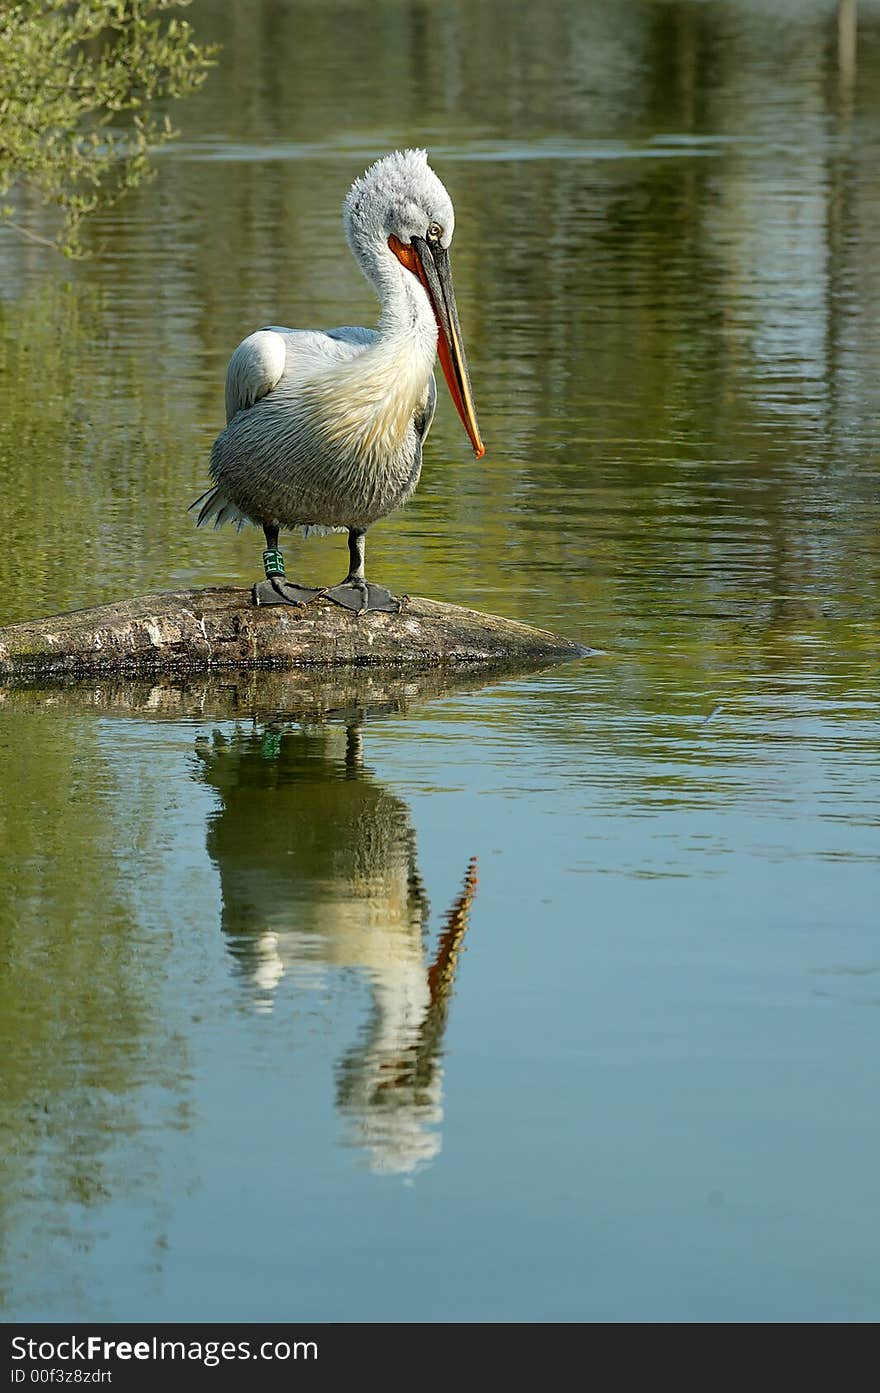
[0,588,589,678]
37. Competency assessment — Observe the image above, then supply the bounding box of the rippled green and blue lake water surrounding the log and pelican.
[0,0,880,1322]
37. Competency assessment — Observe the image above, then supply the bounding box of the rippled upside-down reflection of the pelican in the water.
[196,724,476,1173]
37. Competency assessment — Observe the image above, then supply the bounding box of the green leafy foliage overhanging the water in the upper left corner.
[0,0,213,256]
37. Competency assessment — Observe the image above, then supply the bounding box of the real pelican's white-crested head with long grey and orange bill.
[345,150,486,460]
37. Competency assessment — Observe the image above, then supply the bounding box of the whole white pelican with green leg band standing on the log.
[192,150,485,613]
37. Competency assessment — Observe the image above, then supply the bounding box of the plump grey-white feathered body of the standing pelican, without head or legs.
[198,326,437,529]
